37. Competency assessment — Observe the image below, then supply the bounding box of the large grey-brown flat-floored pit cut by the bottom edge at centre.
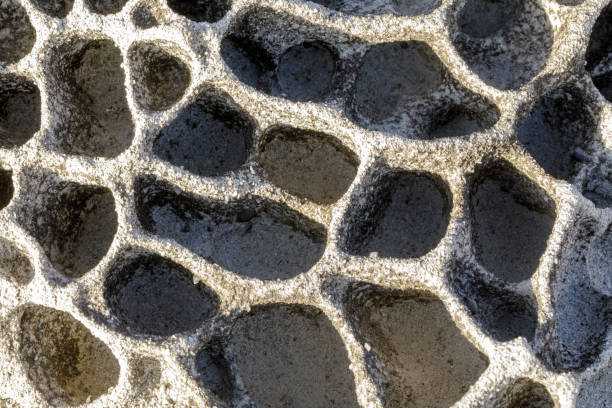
[228,304,359,408]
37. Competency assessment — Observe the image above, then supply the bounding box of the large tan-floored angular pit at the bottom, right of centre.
[345,285,489,408]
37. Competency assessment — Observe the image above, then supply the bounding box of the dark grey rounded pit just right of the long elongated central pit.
[345,170,452,258]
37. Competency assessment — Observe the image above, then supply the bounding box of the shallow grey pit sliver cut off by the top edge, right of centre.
[311,0,441,17]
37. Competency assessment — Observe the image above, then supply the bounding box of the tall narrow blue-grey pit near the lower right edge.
[541,218,612,371]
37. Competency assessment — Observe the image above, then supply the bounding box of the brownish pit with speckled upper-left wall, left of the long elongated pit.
[20,174,118,278]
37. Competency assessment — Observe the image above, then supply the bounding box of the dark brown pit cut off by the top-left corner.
[0,0,36,64]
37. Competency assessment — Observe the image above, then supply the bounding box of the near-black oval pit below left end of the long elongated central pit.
[104,254,219,336]
